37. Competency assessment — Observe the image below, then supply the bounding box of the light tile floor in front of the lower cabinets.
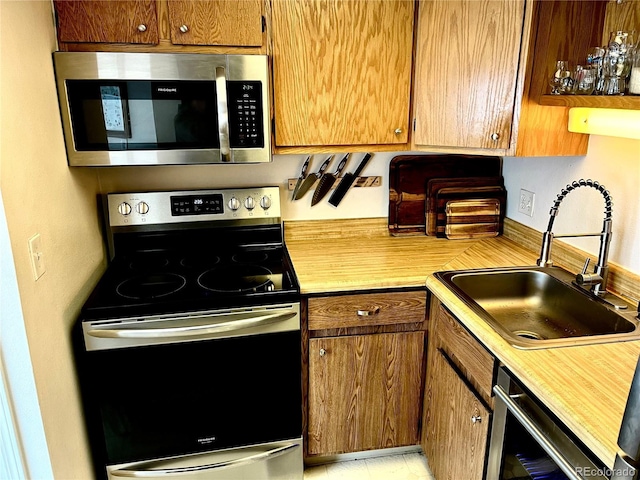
[304,453,434,480]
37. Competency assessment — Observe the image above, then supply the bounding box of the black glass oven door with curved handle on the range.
[78,303,302,478]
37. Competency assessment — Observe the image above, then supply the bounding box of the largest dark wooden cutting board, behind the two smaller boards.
[389,155,502,235]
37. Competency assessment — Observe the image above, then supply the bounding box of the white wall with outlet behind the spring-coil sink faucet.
[503,135,640,276]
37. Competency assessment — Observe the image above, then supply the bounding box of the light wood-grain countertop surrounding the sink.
[285,219,640,468]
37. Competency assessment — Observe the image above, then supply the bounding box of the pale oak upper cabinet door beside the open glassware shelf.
[413,0,524,149]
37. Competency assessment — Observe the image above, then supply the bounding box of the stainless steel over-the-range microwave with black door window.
[53,52,271,166]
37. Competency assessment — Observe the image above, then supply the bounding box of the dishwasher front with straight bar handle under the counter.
[486,367,608,480]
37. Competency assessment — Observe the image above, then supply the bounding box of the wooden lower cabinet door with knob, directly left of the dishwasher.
[423,350,490,480]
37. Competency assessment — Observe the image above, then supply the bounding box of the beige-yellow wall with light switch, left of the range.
[0,0,105,480]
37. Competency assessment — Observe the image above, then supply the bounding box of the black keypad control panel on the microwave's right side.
[227,80,264,148]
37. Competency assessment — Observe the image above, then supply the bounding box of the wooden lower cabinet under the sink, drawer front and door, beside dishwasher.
[421,299,497,480]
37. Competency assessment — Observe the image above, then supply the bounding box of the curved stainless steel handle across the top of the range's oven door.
[87,312,297,338]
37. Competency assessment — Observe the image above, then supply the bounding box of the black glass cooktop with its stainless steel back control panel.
[82,187,299,320]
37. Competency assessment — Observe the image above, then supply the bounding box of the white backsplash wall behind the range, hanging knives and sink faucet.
[100,135,640,276]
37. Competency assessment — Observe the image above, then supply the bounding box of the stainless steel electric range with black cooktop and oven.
[76,187,303,480]
